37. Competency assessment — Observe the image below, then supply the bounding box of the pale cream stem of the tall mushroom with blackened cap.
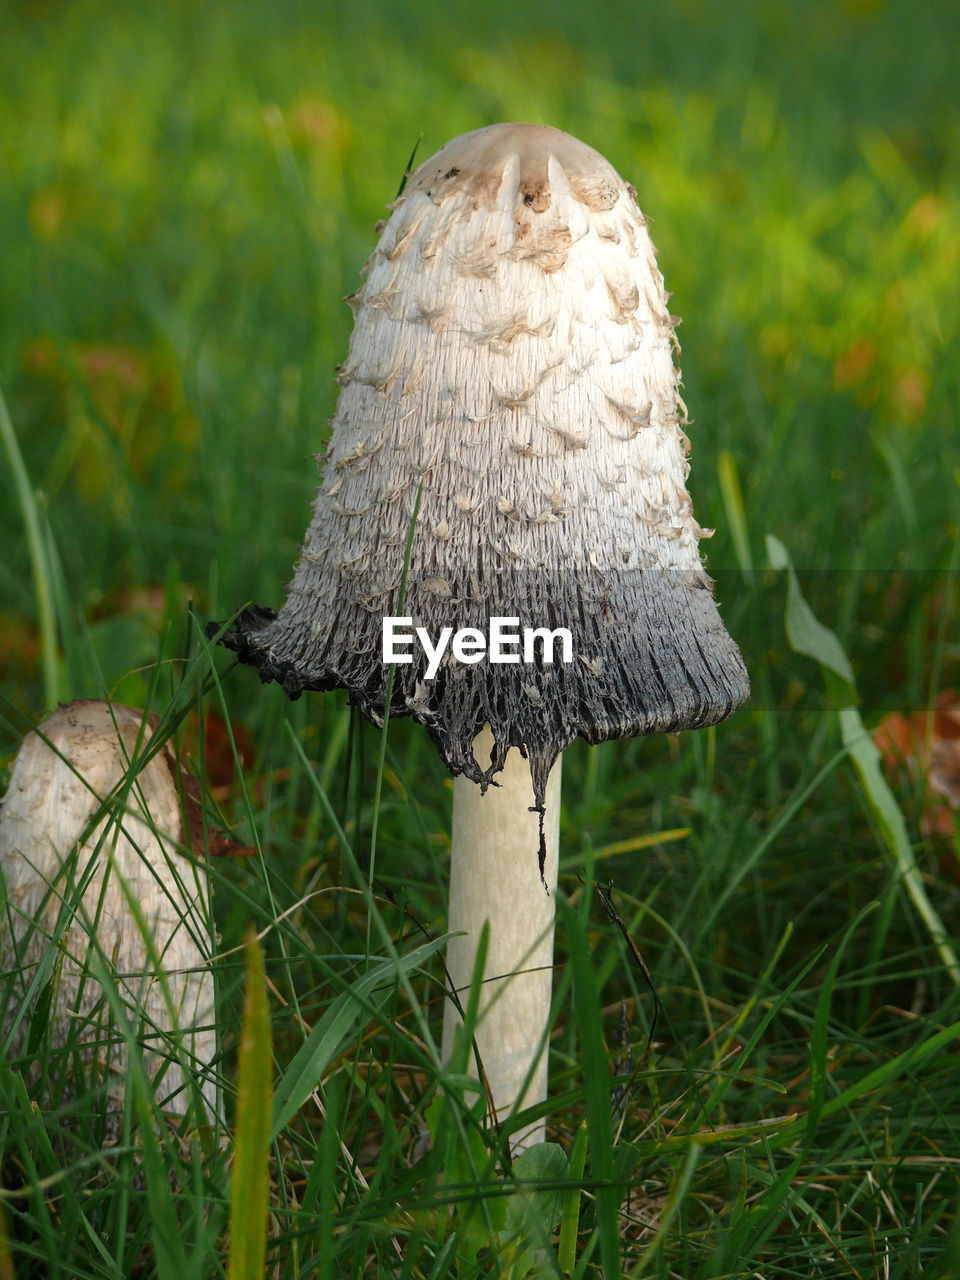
[443,728,561,1153]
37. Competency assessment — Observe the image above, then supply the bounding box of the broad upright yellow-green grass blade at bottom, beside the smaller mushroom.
[227,937,273,1280]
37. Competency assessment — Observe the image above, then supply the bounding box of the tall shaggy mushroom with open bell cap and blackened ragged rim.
[217,124,749,1149]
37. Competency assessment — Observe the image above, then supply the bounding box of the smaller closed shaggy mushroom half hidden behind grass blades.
[0,700,220,1138]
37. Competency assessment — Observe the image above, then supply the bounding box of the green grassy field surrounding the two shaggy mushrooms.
[0,0,960,1280]
